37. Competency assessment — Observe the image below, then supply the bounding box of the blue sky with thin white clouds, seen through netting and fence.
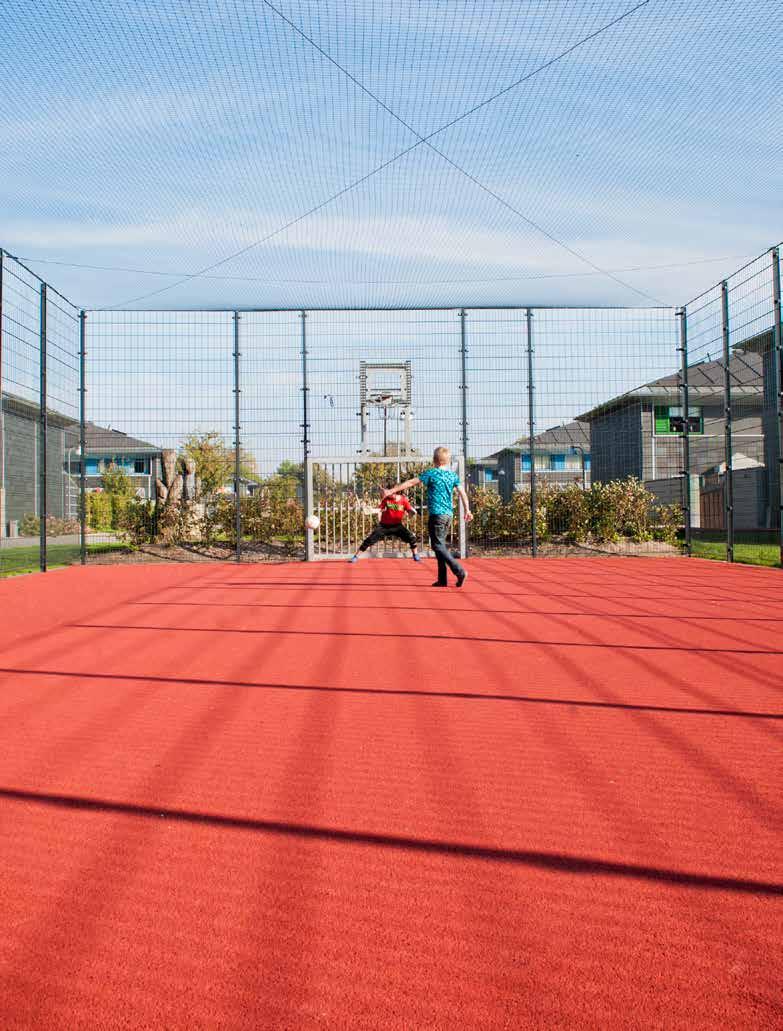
[0,0,783,471]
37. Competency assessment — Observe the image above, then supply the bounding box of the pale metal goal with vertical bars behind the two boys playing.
[304,454,467,562]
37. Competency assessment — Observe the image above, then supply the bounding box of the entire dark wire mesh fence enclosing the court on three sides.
[0,248,781,573]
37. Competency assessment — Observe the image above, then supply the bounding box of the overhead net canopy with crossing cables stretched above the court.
[0,0,783,308]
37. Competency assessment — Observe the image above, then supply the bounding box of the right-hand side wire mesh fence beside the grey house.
[683,247,783,565]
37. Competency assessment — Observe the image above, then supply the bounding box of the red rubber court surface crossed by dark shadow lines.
[0,559,783,1031]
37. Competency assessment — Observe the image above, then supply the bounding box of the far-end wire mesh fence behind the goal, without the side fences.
[88,308,681,559]
